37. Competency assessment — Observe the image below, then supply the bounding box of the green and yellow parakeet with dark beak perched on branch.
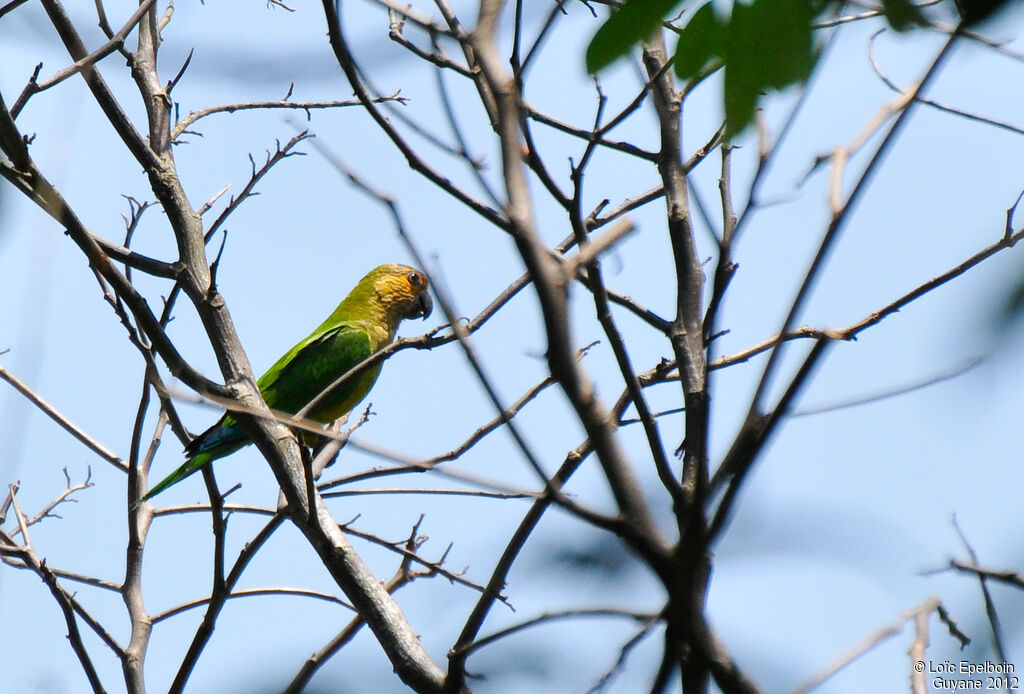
[139,263,433,504]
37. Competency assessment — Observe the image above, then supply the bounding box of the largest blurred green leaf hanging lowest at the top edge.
[724,0,821,136]
